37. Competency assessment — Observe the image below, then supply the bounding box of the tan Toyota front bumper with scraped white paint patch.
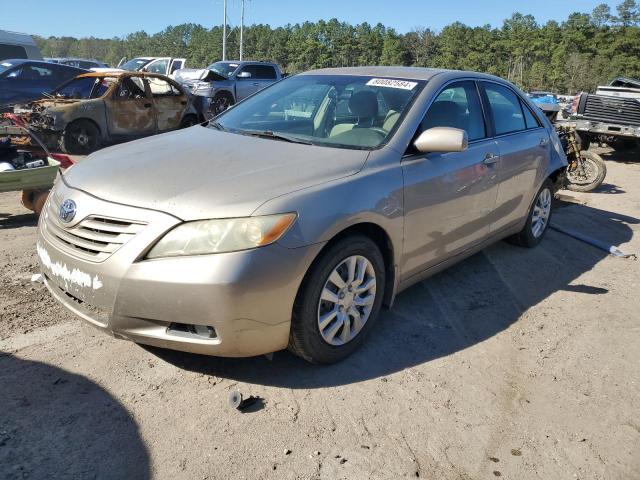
[37,182,323,357]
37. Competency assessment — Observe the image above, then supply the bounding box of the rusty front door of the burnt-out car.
[105,77,156,139]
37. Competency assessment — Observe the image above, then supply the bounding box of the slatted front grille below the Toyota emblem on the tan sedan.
[43,193,146,262]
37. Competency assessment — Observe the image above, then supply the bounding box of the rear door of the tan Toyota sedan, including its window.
[481,81,551,232]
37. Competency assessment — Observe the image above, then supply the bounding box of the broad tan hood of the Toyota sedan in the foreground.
[64,126,369,220]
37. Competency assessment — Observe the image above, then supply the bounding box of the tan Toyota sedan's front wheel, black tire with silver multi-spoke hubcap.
[289,235,386,364]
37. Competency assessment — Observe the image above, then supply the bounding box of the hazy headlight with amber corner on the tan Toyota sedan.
[147,213,296,258]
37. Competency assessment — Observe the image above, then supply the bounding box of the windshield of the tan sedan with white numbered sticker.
[211,75,425,149]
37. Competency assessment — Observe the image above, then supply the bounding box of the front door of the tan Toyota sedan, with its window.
[401,81,499,280]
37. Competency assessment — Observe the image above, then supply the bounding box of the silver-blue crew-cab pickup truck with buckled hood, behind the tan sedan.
[175,60,282,117]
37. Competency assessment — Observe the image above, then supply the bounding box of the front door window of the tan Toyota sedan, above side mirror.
[422,81,487,141]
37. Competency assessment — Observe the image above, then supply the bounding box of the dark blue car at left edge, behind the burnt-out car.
[0,59,88,107]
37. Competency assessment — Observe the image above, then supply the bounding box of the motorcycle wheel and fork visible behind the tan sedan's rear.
[555,123,607,192]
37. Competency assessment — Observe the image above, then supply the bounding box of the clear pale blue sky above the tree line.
[0,0,622,38]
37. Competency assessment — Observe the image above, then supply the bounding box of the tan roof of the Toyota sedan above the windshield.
[301,67,504,82]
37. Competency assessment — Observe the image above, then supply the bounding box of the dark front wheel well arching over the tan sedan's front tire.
[300,222,396,306]
